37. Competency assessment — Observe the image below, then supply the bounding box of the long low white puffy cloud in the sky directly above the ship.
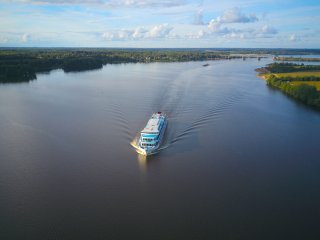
[102,24,173,41]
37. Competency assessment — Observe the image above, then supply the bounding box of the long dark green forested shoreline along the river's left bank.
[0,48,245,83]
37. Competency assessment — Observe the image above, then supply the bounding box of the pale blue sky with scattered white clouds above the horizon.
[0,0,320,48]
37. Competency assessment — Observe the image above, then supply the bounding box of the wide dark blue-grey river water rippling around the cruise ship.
[0,59,320,239]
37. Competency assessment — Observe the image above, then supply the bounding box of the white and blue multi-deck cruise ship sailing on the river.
[138,112,168,155]
